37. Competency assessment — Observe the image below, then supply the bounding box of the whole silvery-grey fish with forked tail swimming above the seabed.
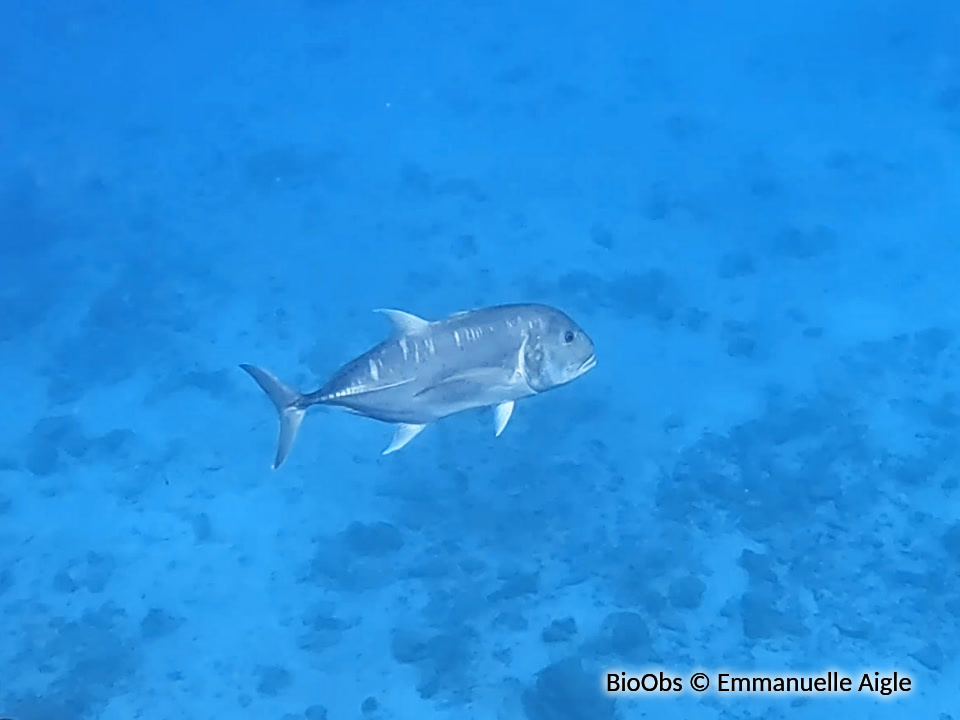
[240,303,597,470]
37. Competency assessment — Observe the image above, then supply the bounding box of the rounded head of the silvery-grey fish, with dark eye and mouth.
[523,310,597,392]
